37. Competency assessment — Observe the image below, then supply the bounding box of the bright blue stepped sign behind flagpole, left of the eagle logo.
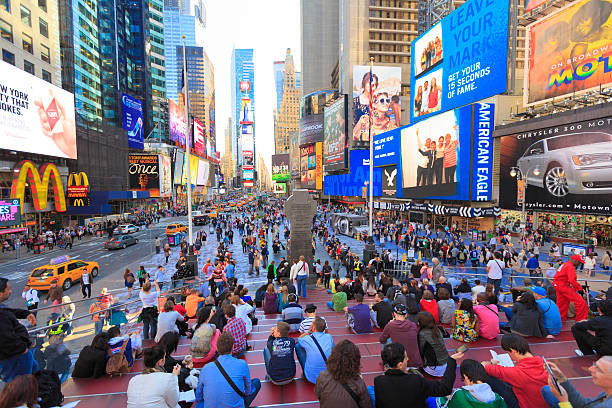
[323,150,382,197]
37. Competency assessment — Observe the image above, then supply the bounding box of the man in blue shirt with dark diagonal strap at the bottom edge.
[196,333,261,408]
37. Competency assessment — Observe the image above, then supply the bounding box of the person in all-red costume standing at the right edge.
[553,255,588,322]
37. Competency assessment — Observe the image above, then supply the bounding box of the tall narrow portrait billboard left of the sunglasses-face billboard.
[323,95,348,171]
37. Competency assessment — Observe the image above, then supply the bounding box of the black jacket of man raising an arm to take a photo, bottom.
[374,358,457,408]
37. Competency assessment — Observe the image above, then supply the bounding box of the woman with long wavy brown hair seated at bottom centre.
[314,340,372,408]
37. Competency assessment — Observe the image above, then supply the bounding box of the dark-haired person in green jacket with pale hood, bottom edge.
[430,359,506,408]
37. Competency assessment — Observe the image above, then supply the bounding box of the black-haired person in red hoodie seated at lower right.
[482,334,548,408]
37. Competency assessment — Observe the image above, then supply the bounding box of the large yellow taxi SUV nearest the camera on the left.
[28,255,100,290]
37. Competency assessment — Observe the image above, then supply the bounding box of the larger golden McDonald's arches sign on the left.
[11,160,66,212]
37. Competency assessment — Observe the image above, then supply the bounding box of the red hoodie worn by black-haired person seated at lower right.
[485,356,548,408]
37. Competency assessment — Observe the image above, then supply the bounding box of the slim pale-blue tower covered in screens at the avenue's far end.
[231,48,255,175]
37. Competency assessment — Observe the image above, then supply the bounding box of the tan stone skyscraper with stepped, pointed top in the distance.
[274,49,300,154]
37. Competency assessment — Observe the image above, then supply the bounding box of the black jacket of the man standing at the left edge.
[0,303,31,361]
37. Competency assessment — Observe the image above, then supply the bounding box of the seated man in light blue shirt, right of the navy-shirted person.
[295,317,334,384]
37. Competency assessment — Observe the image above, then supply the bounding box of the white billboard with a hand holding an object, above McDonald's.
[0,61,77,159]
